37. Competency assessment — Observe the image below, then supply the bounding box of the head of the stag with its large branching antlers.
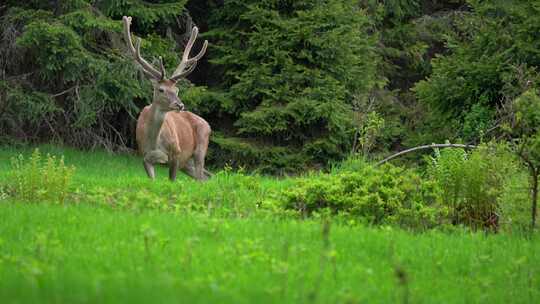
[123,16,208,112]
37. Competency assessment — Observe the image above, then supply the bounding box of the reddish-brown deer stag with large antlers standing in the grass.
[123,16,211,181]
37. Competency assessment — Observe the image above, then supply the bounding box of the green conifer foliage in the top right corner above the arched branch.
[414,0,540,136]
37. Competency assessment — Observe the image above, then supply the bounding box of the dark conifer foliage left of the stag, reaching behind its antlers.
[0,0,186,149]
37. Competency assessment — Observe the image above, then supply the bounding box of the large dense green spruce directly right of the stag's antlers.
[206,0,379,169]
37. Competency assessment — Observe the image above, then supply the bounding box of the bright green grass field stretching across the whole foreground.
[0,146,540,303]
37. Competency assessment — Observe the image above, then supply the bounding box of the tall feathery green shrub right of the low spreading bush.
[428,144,517,229]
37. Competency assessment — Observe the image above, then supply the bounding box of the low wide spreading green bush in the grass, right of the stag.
[279,162,446,228]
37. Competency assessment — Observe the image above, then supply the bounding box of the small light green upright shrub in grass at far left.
[5,149,75,203]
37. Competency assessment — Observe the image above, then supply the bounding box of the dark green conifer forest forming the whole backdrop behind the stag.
[0,0,540,174]
